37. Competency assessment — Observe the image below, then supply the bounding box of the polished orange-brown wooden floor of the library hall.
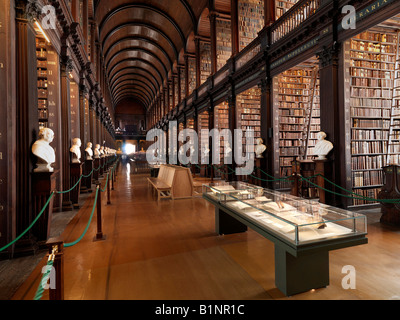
[13,167,400,300]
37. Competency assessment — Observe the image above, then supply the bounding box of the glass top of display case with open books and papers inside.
[203,182,367,246]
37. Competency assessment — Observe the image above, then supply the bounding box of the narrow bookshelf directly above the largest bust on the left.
[36,37,49,129]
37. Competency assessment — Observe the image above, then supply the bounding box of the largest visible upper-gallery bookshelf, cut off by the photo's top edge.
[239,0,264,50]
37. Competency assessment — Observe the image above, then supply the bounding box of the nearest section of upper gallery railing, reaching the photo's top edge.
[271,0,321,44]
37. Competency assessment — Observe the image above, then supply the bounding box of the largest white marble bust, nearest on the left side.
[32,128,56,172]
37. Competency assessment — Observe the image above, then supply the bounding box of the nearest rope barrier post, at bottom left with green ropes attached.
[47,239,64,301]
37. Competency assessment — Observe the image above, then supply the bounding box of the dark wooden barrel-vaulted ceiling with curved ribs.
[95,0,211,108]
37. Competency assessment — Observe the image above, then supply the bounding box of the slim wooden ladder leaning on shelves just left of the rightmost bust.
[299,67,319,160]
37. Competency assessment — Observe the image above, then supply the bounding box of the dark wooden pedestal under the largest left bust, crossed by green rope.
[31,172,56,245]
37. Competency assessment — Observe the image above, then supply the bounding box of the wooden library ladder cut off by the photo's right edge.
[386,30,400,165]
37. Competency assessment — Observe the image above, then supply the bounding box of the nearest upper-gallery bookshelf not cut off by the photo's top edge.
[216,19,232,71]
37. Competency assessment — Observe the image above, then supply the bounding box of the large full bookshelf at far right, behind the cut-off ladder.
[345,28,397,206]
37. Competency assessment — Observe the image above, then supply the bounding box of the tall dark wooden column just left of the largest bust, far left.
[15,1,39,245]
